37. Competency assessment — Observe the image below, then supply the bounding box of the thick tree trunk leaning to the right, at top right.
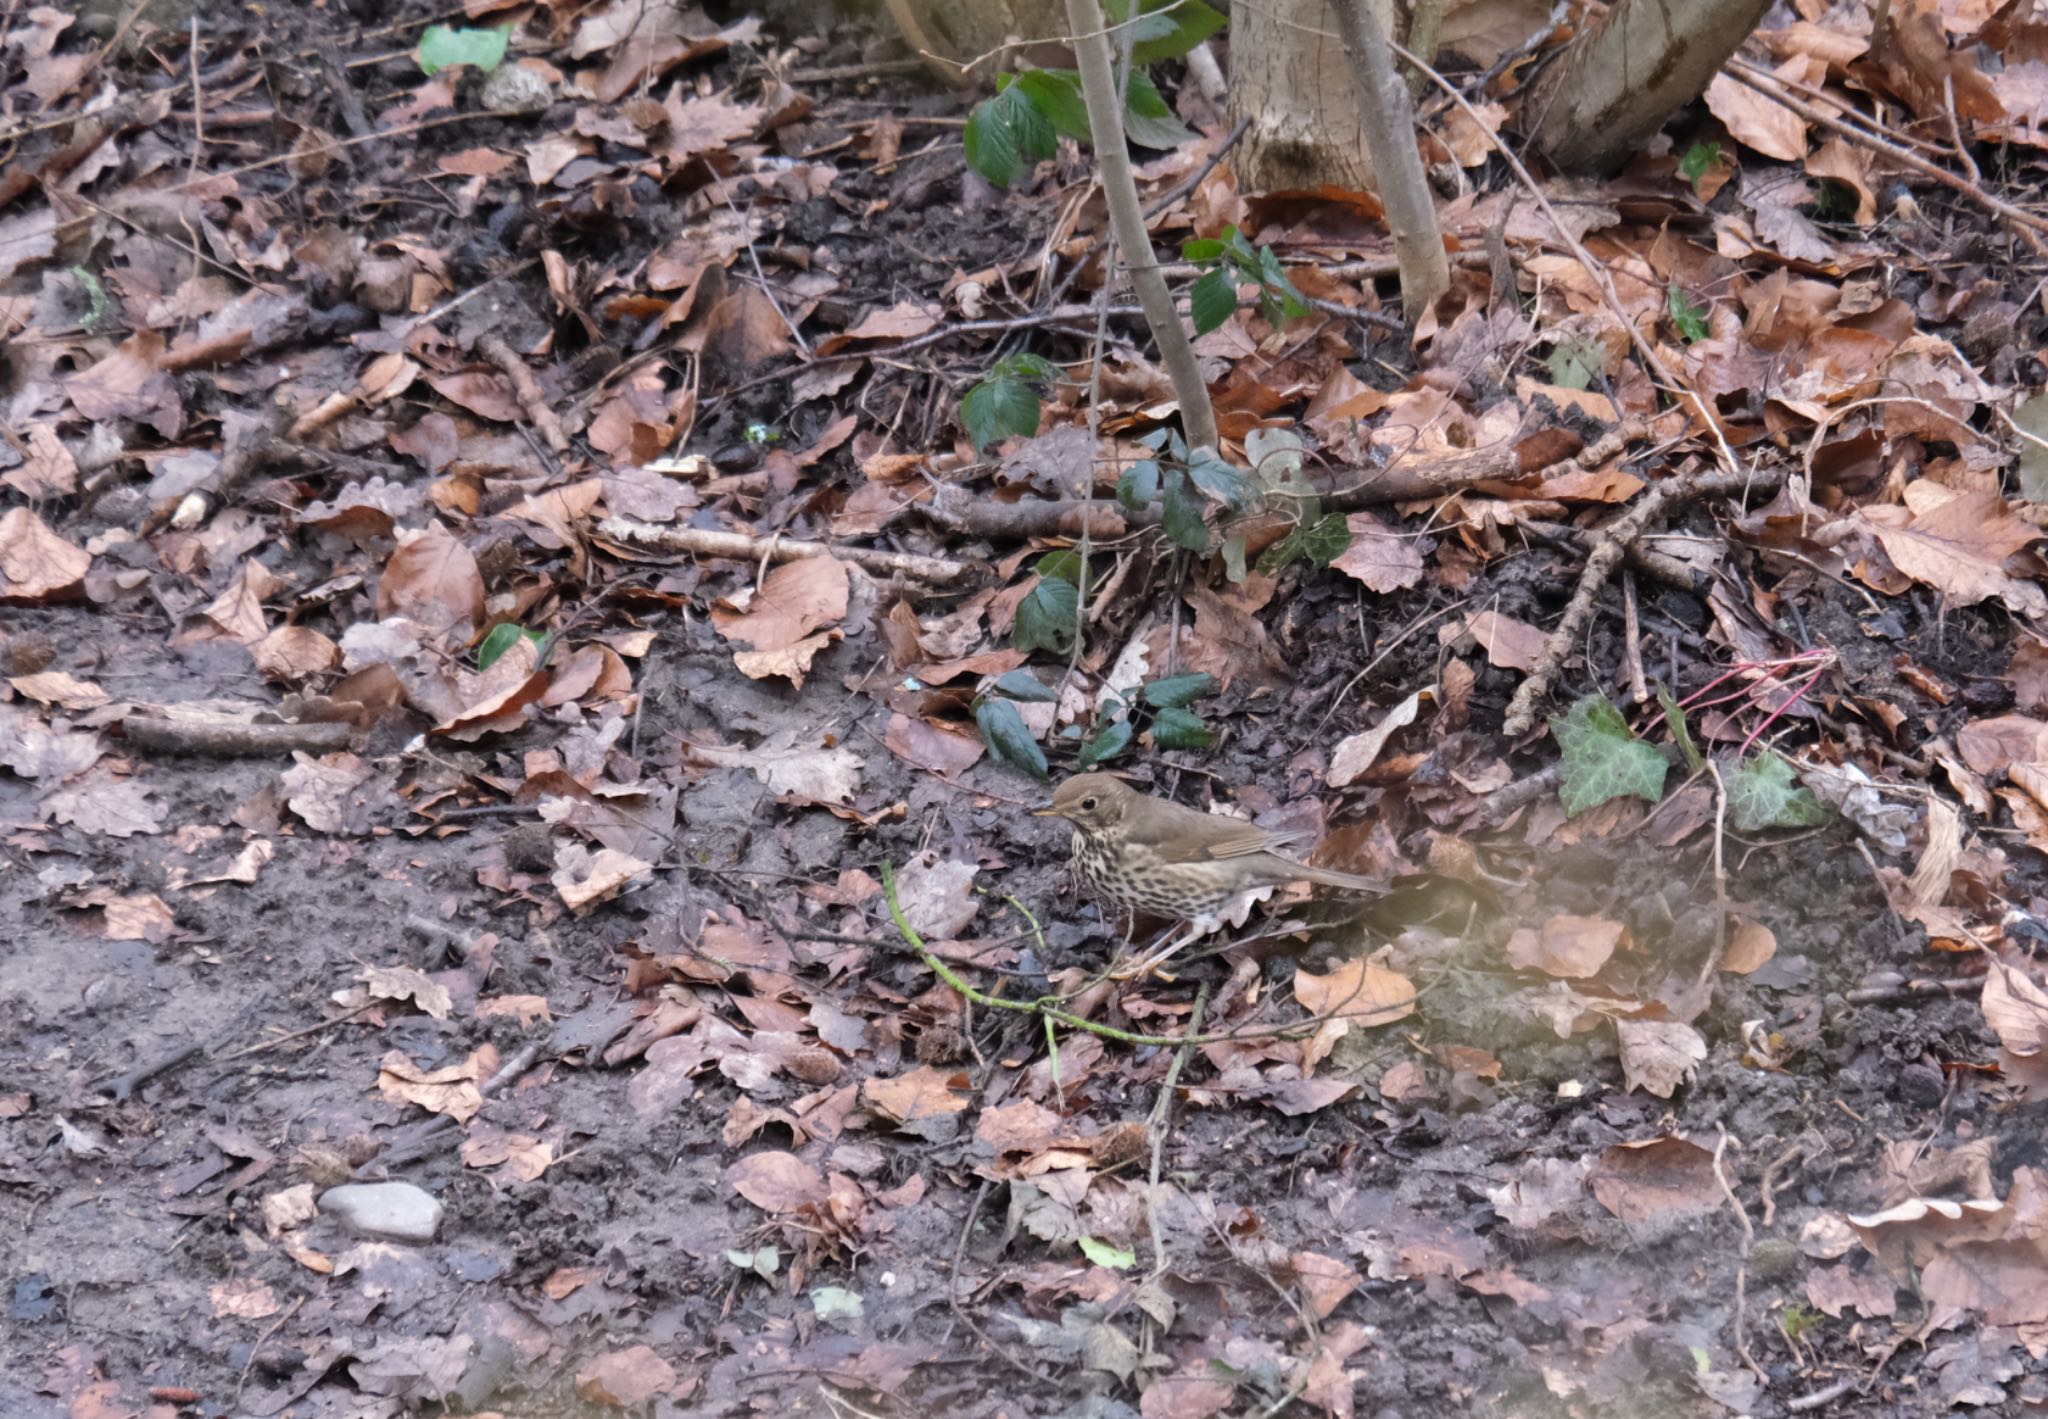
[1522,0,1769,174]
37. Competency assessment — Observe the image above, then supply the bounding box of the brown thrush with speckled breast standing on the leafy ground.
[1032,774,1384,971]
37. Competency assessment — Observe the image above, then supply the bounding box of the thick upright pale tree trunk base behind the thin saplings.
[1227,0,1384,192]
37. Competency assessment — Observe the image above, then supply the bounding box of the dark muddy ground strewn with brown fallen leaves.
[0,0,2048,1419]
